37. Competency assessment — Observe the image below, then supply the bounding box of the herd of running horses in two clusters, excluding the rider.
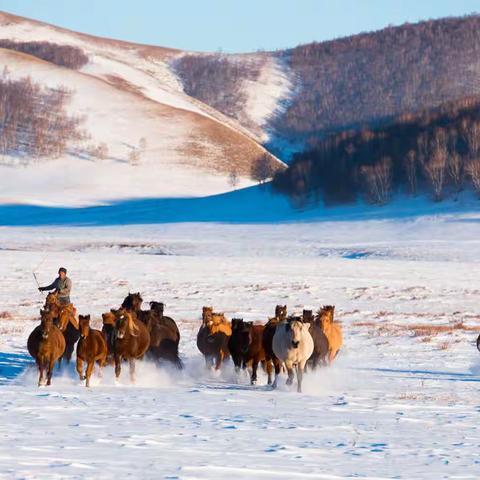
[27,293,343,392]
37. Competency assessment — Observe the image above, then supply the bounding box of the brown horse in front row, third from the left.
[114,308,150,382]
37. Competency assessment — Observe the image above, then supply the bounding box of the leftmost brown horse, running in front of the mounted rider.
[27,310,65,386]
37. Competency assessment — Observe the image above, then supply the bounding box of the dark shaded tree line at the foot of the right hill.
[273,97,480,205]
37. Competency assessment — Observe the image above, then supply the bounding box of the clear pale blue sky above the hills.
[0,0,480,52]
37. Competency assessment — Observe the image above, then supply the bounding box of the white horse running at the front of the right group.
[272,320,313,392]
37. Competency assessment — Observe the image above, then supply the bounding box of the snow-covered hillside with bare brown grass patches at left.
[0,13,283,205]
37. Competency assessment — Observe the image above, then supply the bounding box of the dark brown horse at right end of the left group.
[147,302,183,370]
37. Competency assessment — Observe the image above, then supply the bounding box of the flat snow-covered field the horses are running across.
[0,216,480,479]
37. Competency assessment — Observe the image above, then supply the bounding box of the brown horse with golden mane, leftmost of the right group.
[197,307,232,370]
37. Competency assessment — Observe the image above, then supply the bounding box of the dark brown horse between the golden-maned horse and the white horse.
[228,318,272,385]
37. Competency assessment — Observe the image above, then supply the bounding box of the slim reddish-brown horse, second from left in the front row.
[77,315,108,387]
